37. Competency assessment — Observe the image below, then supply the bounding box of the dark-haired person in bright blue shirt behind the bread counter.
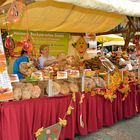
[13,50,29,79]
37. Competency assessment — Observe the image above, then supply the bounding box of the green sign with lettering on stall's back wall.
[10,30,69,56]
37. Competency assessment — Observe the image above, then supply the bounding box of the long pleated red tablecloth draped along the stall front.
[0,82,140,140]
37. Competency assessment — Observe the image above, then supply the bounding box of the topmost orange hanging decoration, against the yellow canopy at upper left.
[6,1,25,23]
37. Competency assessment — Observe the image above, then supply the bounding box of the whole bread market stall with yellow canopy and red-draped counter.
[0,0,140,140]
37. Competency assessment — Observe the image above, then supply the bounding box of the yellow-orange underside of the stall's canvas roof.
[0,0,140,33]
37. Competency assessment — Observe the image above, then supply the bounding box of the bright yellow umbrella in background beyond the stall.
[96,34,124,42]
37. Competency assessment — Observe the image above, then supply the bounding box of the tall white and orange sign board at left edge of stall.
[0,33,13,101]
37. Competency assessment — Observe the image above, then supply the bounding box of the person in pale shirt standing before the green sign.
[38,44,57,68]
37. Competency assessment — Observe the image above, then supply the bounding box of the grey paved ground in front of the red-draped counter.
[74,114,140,140]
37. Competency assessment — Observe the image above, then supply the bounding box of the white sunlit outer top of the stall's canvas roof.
[56,0,140,17]
